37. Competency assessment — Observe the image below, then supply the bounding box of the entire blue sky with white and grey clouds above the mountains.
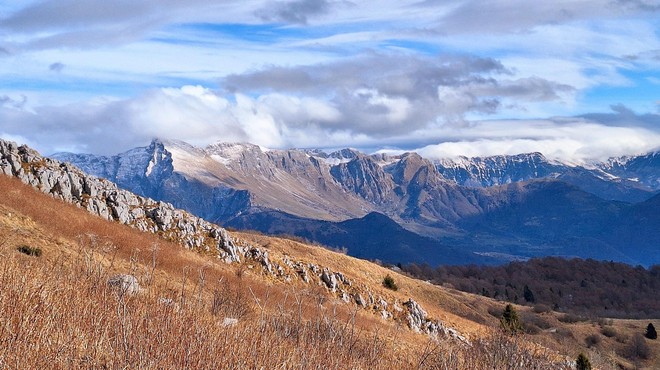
[0,0,660,163]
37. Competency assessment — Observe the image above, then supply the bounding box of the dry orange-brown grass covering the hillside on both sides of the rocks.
[0,176,657,369]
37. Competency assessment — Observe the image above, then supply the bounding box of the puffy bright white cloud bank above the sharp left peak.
[0,86,352,154]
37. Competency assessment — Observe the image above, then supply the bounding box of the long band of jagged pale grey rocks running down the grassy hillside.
[0,140,468,343]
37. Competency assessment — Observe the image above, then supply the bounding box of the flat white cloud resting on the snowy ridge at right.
[414,118,660,164]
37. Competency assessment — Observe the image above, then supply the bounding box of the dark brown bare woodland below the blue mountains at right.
[400,257,660,318]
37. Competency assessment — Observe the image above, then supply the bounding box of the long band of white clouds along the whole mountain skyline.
[0,86,660,163]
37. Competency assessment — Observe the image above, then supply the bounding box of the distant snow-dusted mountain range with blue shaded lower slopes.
[53,140,660,265]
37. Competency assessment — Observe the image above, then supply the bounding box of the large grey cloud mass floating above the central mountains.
[221,53,574,130]
